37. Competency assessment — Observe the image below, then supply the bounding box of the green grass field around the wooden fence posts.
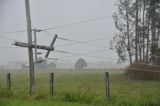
[0,71,160,106]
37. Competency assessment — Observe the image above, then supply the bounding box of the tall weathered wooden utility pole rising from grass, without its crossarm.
[25,0,35,95]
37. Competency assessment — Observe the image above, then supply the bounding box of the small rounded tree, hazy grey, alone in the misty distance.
[74,58,87,70]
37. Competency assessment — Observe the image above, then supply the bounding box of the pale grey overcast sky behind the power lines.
[0,0,125,68]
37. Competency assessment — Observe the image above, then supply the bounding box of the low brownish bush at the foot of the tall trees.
[125,63,160,80]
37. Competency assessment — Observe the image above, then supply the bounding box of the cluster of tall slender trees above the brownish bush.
[111,0,160,65]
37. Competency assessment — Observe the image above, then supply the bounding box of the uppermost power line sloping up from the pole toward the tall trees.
[43,16,112,31]
